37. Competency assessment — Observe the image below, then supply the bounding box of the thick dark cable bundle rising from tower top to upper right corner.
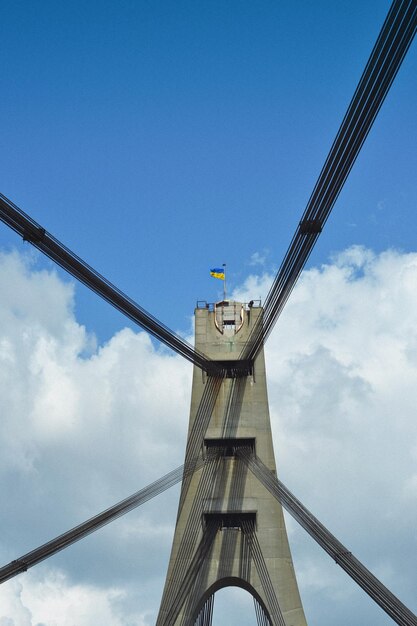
[241,0,417,360]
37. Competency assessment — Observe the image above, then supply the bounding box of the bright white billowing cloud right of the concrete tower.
[232,247,417,624]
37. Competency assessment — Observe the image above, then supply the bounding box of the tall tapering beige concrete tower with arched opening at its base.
[157,301,306,626]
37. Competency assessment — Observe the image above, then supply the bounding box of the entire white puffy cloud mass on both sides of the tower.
[0,247,417,626]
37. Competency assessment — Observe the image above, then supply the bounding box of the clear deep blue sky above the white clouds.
[0,0,417,626]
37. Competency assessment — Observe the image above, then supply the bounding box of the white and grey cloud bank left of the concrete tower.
[0,254,191,626]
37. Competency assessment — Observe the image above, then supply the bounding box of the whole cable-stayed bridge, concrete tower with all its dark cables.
[0,0,417,626]
